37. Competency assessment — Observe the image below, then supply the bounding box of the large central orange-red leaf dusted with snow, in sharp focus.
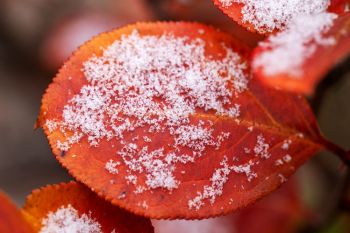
[38,22,337,219]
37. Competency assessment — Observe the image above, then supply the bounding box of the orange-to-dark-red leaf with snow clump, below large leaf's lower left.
[22,182,153,233]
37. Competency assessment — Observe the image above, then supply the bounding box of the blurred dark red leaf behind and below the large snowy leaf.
[152,178,308,233]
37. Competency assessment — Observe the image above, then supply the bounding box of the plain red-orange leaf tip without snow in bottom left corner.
[0,192,34,233]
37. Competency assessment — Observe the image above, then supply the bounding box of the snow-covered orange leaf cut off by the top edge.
[213,0,348,34]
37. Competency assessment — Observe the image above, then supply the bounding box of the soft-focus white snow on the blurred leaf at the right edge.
[253,12,337,76]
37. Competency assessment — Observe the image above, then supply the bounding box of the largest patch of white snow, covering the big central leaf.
[46,30,248,192]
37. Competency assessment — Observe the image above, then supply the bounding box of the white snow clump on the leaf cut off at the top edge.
[219,0,330,33]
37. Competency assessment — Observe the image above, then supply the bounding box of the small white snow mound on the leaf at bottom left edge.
[40,205,102,233]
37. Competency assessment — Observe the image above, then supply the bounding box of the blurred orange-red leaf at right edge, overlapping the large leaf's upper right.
[253,13,350,95]
